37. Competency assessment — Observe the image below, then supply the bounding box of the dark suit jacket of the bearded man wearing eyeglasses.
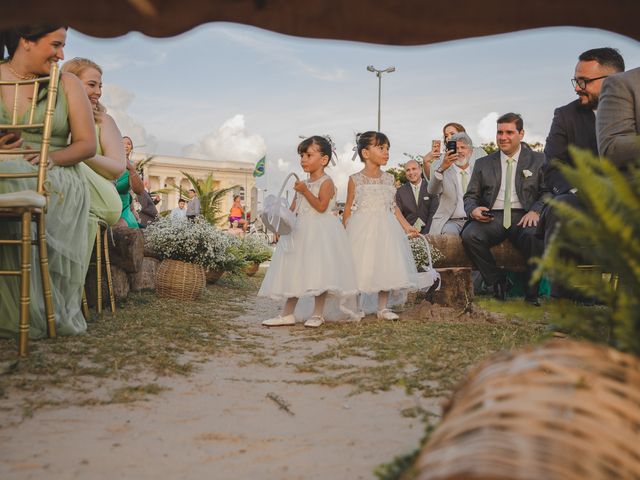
[544,100,598,196]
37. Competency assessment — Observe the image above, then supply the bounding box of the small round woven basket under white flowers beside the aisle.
[156,259,205,300]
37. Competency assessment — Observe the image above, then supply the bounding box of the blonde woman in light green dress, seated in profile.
[62,58,125,264]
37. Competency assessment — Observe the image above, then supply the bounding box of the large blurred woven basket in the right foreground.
[411,340,640,480]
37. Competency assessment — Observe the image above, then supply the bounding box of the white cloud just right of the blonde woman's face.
[102,85,158,152]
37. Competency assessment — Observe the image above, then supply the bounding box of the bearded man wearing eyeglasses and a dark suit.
[537,47,624,297]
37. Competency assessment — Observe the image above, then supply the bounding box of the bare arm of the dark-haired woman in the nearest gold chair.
[50,73,97,167]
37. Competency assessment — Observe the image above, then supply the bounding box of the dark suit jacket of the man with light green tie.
[464,147,545,217]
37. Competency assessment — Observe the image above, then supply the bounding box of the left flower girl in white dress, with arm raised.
[258,136,357,327]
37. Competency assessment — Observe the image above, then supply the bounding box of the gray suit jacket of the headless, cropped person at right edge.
[596,68,640,168]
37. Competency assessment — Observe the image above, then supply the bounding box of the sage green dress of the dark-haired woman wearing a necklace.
[0,72,90,338]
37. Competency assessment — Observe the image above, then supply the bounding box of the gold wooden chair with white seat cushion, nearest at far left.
[0,63,59,356]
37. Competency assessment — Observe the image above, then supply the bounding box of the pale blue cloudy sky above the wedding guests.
[65,23,640,199]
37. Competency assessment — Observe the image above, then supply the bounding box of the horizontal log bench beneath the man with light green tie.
[427,235,525,272]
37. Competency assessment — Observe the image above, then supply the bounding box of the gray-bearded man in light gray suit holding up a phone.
[427,132,475,235]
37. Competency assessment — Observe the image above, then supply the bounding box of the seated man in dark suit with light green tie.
[462,113,544,306]
